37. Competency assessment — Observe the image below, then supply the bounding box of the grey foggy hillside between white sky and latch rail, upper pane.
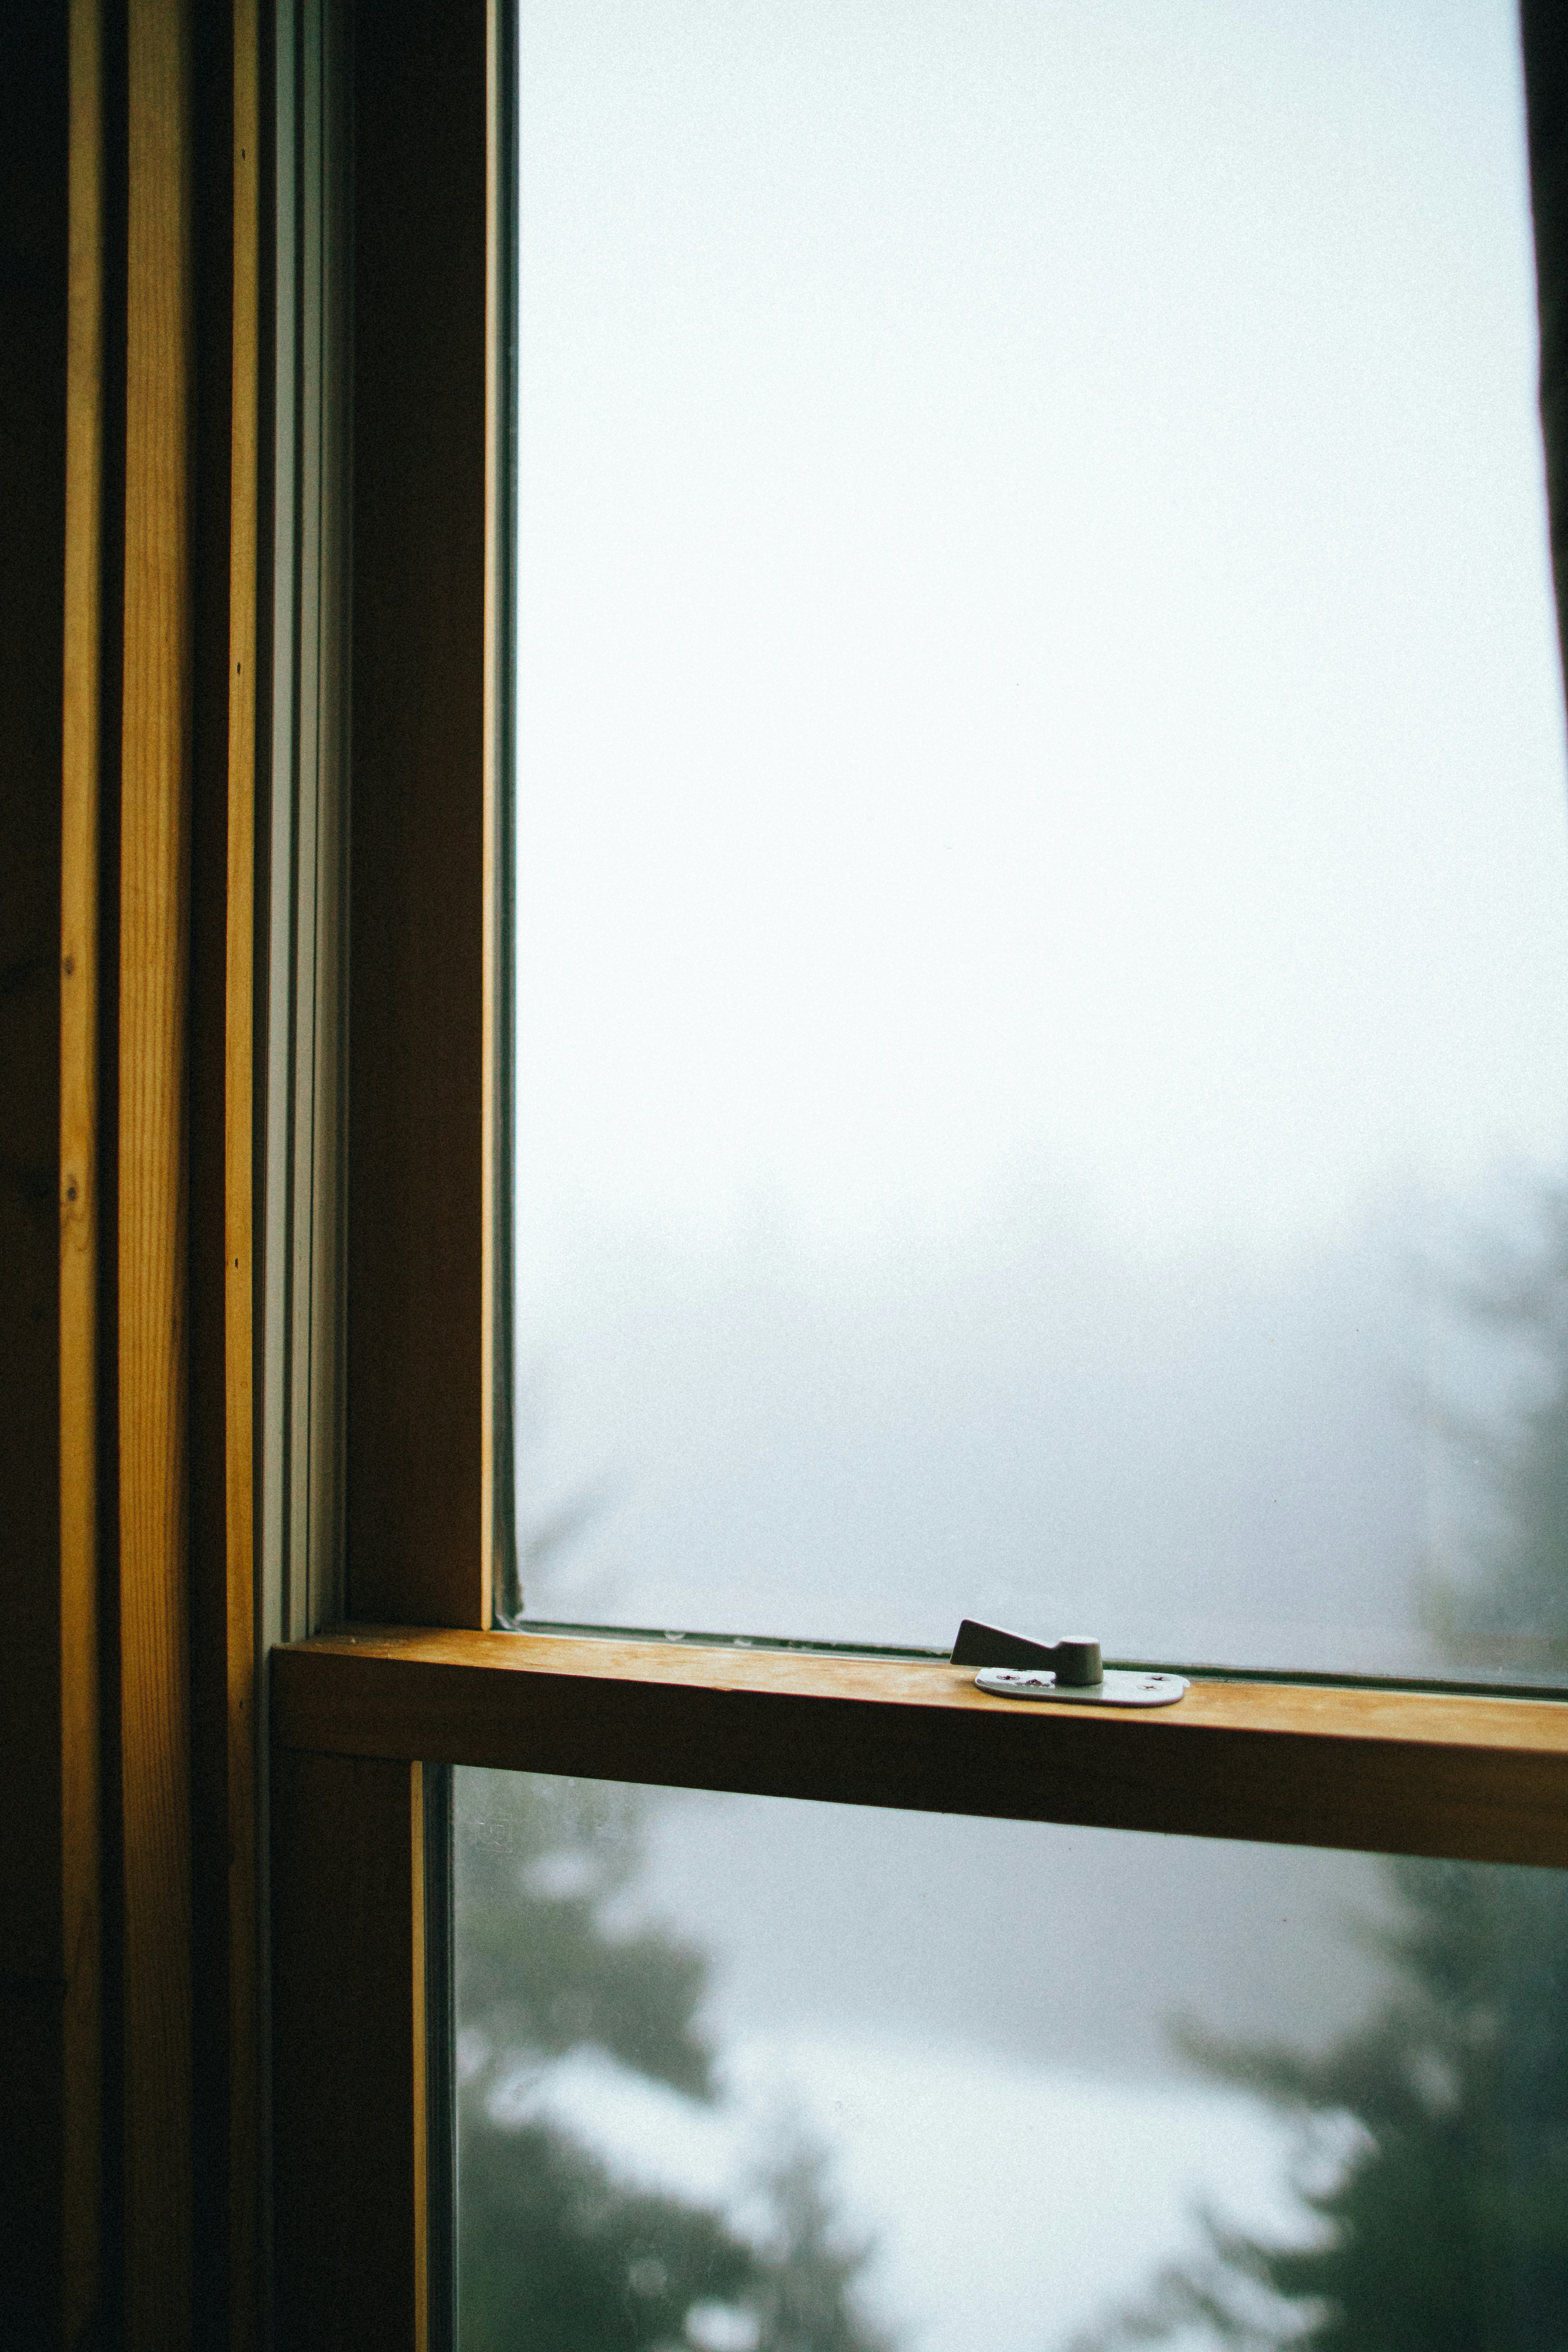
[522,1171,1521,1670]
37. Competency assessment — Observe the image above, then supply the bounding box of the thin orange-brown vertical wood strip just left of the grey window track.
[223,0,261,2352]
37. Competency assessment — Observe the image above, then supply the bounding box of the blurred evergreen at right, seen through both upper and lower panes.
[1074,1192,1568,2352]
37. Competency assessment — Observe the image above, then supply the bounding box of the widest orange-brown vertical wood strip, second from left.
[120,0,193,2352]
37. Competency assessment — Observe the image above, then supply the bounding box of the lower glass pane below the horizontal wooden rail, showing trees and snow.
[456,1771,1568,2352]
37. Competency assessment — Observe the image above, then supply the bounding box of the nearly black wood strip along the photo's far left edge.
[0,7,73,2345]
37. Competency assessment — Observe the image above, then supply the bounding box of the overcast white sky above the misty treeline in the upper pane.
[519,0,1568,1270]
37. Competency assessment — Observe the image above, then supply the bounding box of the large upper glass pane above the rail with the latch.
[517,0,1568,1679]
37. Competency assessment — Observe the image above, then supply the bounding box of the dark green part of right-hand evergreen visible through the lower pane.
[1079,1861,1568,2352]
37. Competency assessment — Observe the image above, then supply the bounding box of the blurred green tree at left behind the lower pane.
[456,1773,886,2352]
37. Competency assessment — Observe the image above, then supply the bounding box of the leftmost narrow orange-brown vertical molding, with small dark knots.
[59,0,104,2343]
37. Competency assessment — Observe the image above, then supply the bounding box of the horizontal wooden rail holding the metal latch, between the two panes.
[273,1625,1568,1868]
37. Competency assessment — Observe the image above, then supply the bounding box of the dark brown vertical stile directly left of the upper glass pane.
[345,0,486,1628]
